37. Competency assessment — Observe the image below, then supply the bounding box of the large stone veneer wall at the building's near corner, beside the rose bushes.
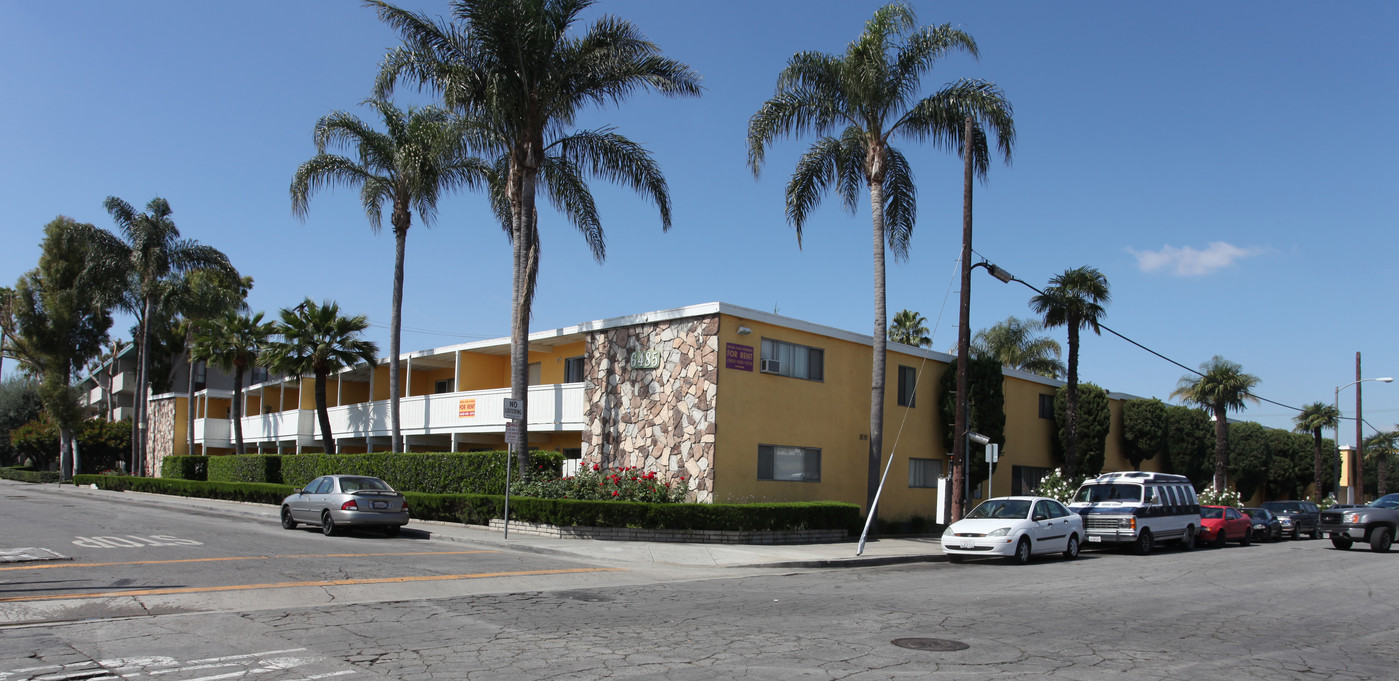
[582,315,719,502]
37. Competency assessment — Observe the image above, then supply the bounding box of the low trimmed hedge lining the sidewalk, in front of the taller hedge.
[73,475,860,531]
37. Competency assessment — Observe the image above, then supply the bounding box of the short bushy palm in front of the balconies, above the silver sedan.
[262,298,379,454]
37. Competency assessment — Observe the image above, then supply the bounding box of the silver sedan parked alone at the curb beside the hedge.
[281,475,409,537]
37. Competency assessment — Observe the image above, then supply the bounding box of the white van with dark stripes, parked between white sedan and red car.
[1069,471,1200,554]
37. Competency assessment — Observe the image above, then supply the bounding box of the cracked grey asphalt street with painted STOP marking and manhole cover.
[0,487,1399,681]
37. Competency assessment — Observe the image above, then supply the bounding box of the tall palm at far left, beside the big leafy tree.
[94,196,238,475]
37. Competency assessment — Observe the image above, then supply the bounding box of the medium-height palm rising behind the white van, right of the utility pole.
[1030,267,1112,478]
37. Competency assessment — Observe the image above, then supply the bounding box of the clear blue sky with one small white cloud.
[0,0,1399,443]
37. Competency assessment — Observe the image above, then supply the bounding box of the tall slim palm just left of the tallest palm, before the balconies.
[291,99,491,452]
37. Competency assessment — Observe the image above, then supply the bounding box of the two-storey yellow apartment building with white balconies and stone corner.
[148,302,1153,519]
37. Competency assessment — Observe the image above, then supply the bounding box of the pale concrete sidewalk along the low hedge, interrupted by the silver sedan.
[19,485,946,568]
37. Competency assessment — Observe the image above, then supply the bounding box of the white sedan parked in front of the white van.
[943,496,1083,564]
